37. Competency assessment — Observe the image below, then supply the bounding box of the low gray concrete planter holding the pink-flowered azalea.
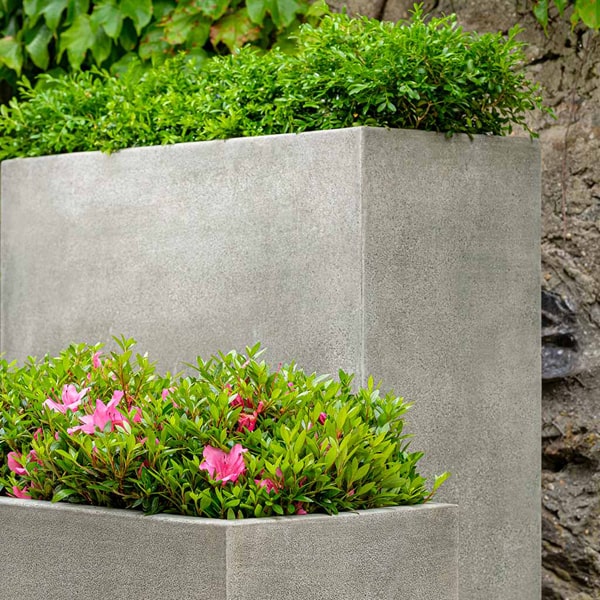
[0,498,458,600]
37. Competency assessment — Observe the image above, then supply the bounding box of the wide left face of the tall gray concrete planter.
[1,130,361,372]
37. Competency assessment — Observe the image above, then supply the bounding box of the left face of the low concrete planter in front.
[0,498,227,600]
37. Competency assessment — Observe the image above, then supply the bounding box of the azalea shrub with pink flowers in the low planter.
[0,338,447,519]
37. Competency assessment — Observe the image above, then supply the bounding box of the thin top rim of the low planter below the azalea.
[0,496,458,527]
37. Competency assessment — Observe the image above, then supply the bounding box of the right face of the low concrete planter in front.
[227,505,458,600]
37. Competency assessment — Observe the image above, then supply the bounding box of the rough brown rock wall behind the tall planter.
[338,0,600,600]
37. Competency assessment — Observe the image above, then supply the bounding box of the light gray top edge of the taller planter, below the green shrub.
[0,126,538,171]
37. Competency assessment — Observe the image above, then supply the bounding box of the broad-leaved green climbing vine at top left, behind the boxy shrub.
[0,0,324,101]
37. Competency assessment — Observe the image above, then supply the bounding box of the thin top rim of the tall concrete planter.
[0,125,539,168]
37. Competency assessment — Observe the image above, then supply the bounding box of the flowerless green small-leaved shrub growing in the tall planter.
[0,10,542,158]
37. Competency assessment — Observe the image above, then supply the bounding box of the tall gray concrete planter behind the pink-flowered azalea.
[0,128,540,600]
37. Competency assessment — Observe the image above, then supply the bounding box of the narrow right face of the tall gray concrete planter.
[363,130,541,600]
